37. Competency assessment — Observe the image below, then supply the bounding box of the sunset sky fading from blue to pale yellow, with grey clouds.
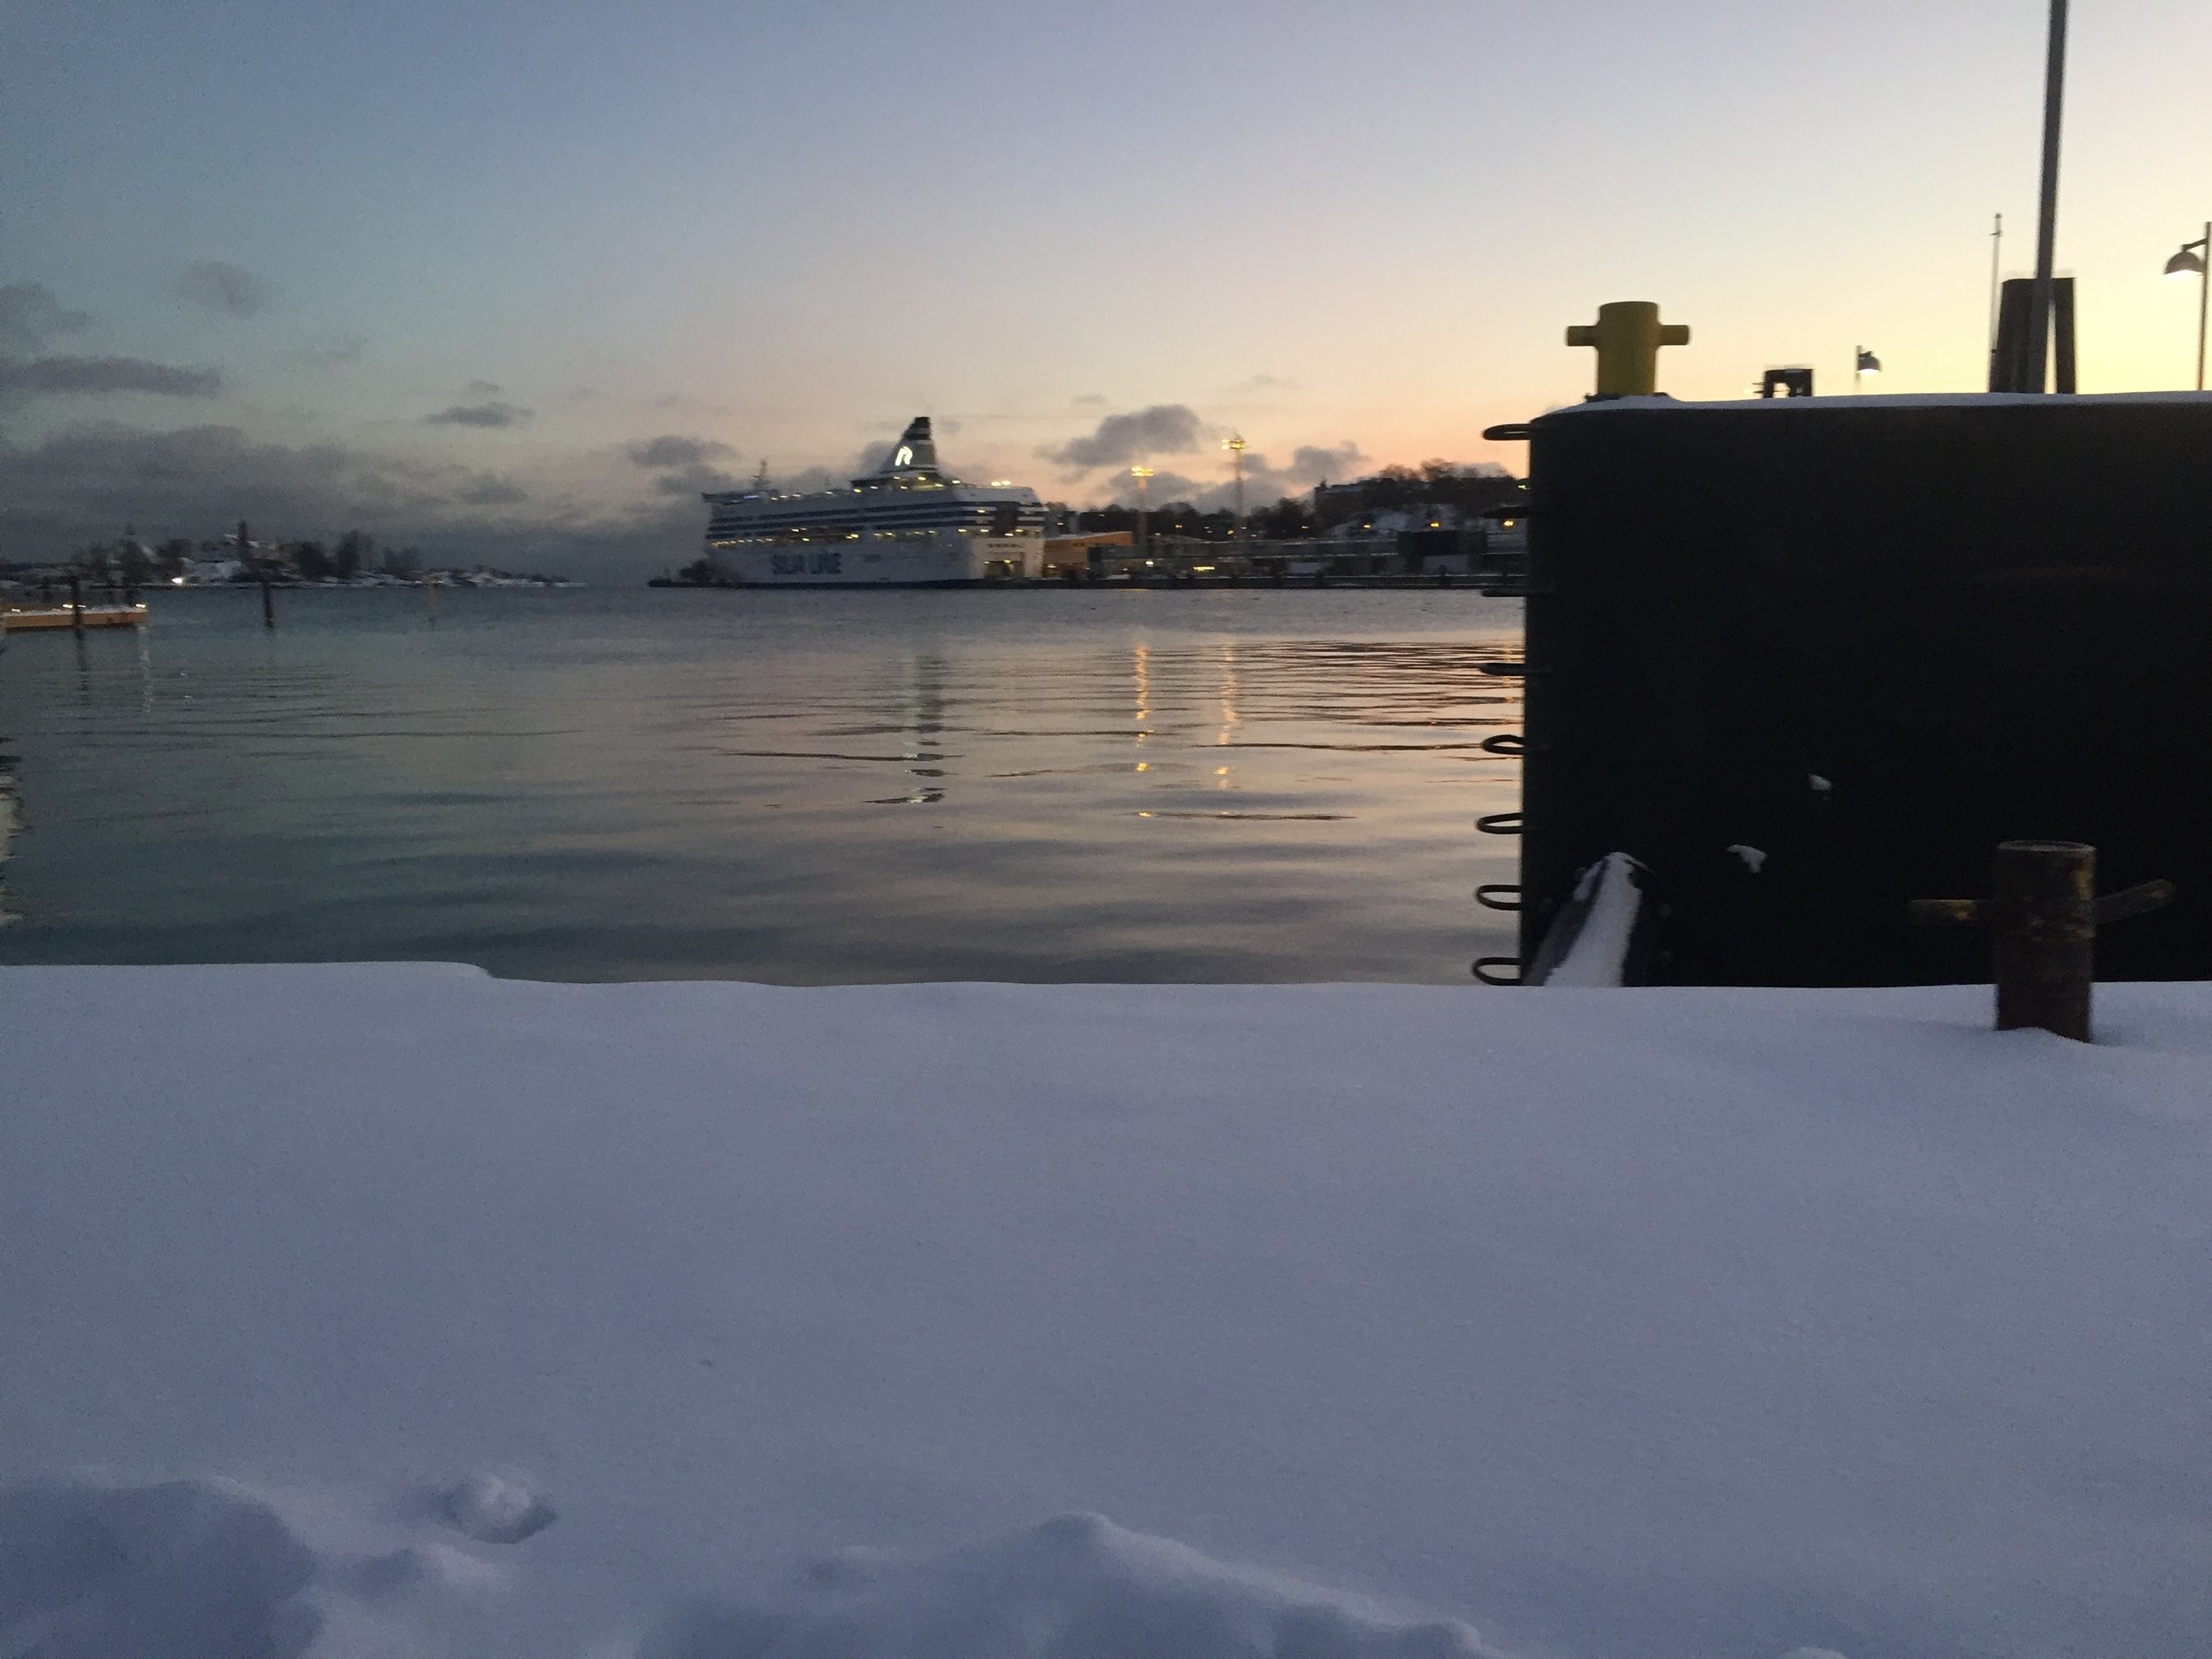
[0,0,2212,575]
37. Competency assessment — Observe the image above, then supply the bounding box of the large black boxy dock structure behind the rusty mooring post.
[1498,394,2212,985]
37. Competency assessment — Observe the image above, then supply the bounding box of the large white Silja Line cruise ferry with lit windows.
[706,416,1044,588]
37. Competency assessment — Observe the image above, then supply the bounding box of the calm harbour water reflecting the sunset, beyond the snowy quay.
[0,588,1520,985]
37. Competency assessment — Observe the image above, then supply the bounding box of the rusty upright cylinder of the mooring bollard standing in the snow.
[1989,841,2097,1042]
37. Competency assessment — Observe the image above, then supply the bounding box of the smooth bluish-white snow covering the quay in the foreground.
[0,967,2212,1659]
